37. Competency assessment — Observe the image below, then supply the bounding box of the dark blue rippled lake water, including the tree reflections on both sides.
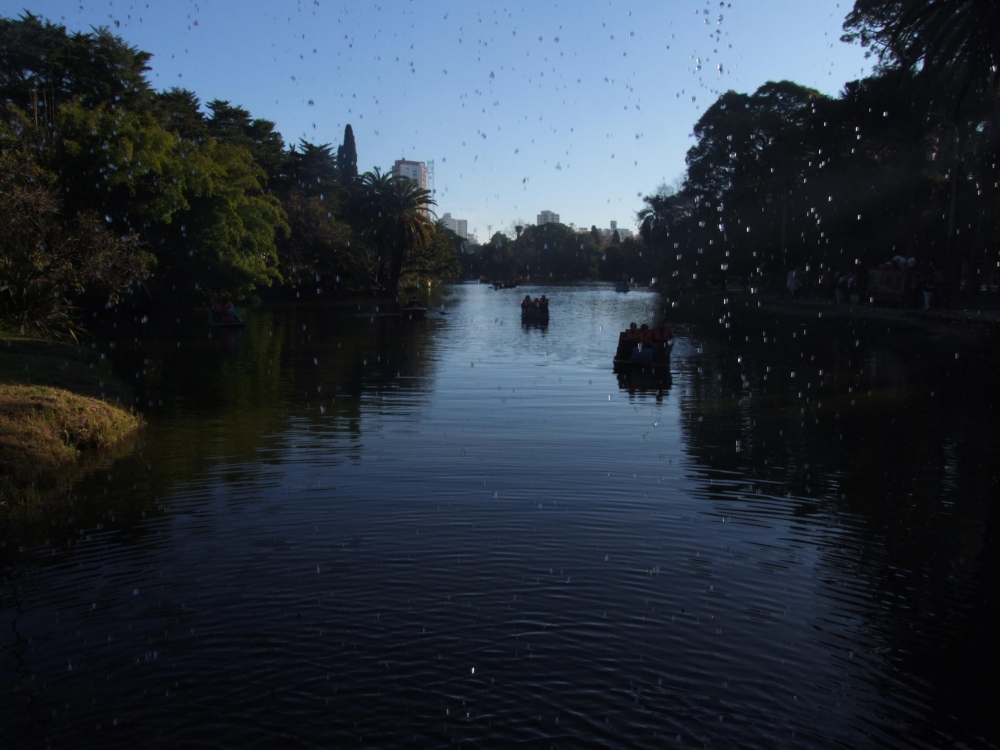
[0,285,1000,748]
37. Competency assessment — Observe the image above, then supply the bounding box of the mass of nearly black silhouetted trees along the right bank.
[637,0,1000,294]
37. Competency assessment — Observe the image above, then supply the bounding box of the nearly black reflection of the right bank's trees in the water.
[674,323,1000,748]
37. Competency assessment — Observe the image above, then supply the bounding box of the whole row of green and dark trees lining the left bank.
[0,13,461,333]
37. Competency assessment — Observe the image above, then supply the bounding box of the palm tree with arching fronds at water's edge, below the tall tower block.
[354,167,436,297]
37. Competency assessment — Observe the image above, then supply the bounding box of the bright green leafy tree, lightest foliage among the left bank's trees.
[50,104,288,298]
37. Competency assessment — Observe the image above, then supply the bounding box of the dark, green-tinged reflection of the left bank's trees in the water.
[0,306,446,562]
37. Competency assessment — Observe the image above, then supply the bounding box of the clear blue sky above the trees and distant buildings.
[11,0,869,241]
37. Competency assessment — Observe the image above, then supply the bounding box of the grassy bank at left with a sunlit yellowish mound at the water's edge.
[0,338,142,515]
